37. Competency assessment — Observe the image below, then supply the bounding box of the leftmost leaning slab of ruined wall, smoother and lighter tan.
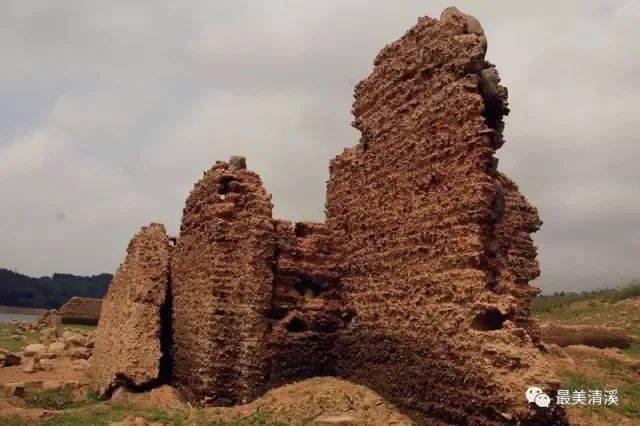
[90,223,171,395]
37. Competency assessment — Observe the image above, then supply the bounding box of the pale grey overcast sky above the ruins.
[0,0,640,292]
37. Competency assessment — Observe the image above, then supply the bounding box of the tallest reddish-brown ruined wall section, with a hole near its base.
[327,9,556,424]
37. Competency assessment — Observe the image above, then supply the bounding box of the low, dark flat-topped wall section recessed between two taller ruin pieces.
[268,220,351,387]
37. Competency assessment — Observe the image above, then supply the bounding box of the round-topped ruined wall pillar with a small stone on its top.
[171,158,275,404]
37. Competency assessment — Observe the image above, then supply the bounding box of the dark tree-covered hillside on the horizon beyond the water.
[0,268,112,309]
